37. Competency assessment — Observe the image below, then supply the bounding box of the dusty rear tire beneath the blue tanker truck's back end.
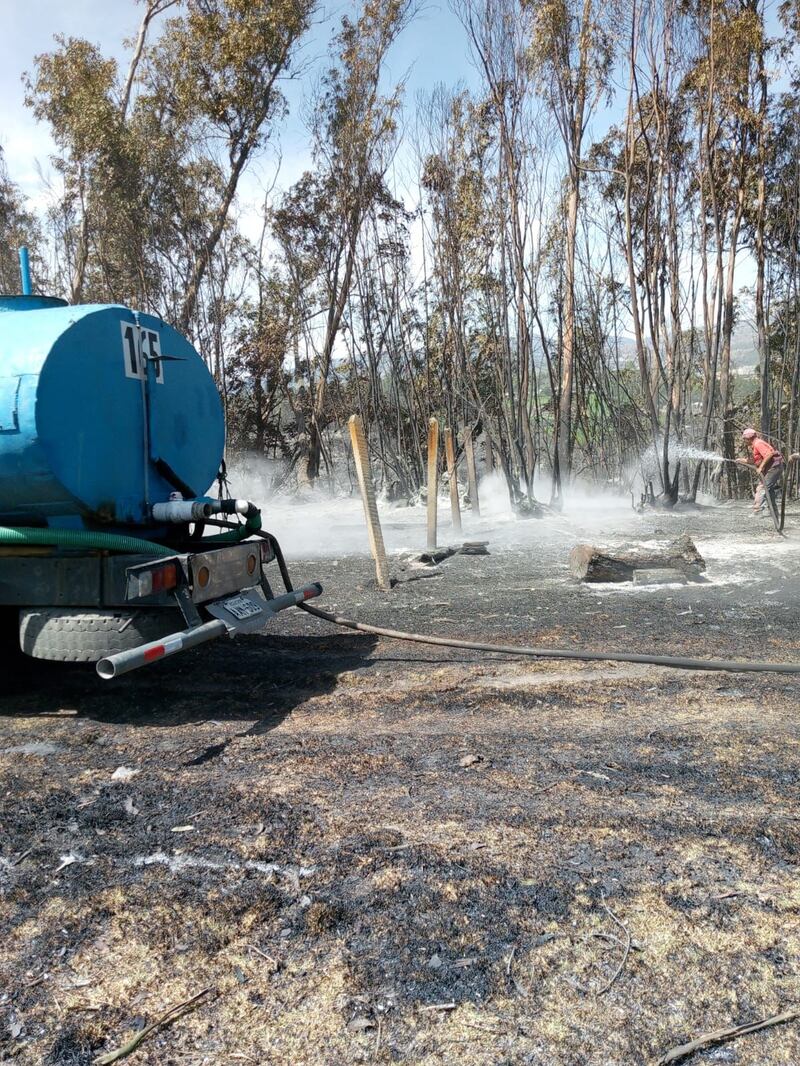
[19,608,186,663]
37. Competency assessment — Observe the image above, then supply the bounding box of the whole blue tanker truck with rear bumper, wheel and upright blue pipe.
[0,249,321,679]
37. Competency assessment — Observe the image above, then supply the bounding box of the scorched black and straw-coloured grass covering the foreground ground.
[0,507,800,1066]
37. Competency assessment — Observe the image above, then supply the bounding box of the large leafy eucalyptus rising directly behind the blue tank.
[27,0,315,332]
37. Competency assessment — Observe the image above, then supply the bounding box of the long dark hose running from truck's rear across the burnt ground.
[258,533,800,674]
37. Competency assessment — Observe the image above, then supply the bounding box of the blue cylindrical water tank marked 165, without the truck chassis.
[0,296,225,527]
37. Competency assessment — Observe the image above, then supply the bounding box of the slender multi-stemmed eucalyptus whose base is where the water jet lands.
[590,0,693,498]
